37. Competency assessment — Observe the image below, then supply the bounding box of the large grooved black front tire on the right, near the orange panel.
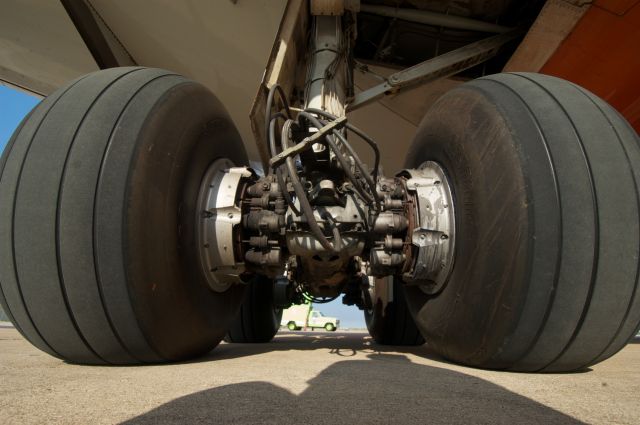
[406,74,640,371]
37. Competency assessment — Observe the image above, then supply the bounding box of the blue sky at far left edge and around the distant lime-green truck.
[0,85,365,328]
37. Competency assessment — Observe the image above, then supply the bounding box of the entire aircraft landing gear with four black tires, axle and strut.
[0,6,640,371]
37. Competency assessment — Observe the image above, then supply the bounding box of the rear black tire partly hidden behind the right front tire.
[364,276,424,346]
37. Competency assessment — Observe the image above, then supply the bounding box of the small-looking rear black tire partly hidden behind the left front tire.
[225,276,283,343]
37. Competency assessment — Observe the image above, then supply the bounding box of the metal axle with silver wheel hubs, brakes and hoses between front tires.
[199,111,455,308]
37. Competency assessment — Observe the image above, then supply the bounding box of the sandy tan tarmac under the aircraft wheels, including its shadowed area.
[0,326,640,425]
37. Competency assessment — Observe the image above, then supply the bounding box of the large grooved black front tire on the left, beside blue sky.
[0,68,247,364]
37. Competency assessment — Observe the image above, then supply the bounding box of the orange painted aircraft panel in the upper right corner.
[540,0,640,132]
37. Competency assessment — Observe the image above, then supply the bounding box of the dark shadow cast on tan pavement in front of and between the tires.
[126,334,581,424]
